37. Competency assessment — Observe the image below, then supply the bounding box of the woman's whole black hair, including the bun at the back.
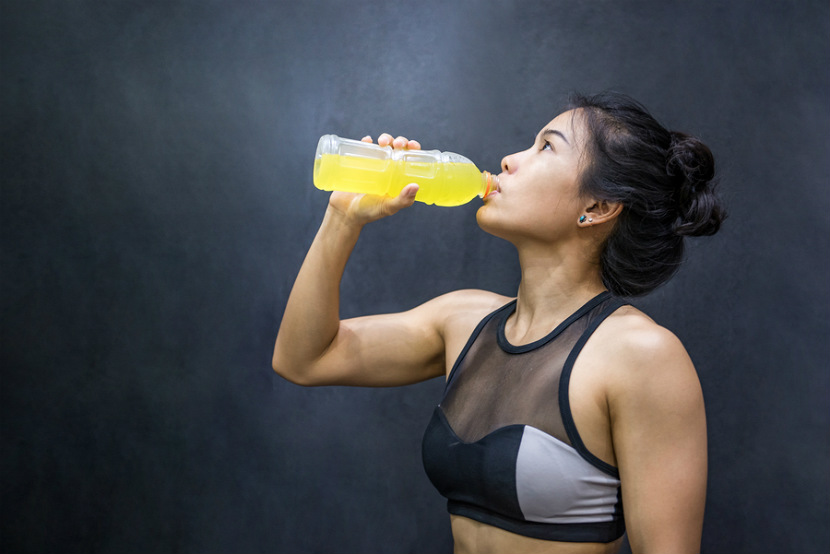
[570,92,726,296]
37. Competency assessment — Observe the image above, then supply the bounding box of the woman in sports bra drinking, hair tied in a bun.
[273,94,724,554]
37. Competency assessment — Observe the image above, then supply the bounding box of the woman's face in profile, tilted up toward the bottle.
[476,110,587,243]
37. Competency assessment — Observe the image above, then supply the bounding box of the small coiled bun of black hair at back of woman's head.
[666,131,726,236]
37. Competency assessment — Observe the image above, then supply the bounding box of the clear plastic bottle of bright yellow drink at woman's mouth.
[314,135,498,206]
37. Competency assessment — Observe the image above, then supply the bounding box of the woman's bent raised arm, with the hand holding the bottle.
[272,136,456,386]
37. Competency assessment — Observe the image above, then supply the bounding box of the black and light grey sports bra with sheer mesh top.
[421,291,625,543]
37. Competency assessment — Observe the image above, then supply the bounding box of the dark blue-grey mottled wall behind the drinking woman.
[0,0,830,554]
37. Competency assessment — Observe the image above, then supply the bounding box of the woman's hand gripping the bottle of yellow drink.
[329,133,421,227]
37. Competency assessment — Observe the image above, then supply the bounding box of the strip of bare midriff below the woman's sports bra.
[450,515,622,554]
